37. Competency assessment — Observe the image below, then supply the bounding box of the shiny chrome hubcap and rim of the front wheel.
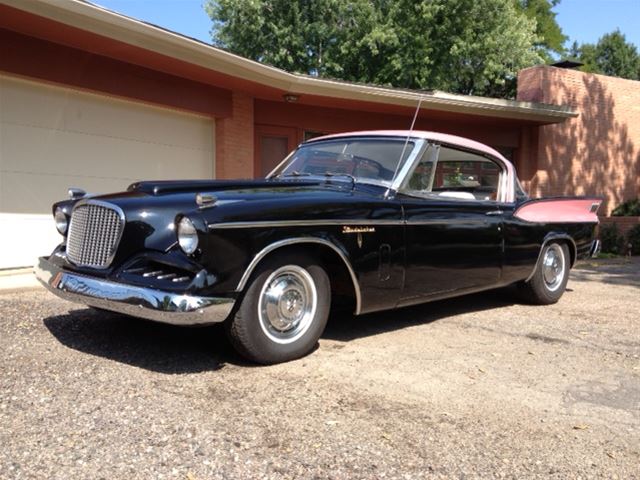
[258,265,318,343]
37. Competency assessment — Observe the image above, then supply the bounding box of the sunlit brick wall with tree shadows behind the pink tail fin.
[518,66,640,214]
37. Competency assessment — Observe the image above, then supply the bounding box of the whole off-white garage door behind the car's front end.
[0,76,215,269]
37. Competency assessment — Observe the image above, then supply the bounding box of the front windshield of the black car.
[270,138,415,187]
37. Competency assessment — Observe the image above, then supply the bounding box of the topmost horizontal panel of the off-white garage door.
[0,77,213,149]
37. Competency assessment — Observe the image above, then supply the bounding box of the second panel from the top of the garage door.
[0,125,213,179]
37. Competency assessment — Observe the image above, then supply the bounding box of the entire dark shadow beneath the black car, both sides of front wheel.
[44,289,515,374]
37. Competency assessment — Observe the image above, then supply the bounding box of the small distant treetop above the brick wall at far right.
[571,30,640,80]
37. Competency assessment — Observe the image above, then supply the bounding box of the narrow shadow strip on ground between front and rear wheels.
[322,287,517,342]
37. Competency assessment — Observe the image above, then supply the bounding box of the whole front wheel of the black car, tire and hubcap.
[227,252,331,364]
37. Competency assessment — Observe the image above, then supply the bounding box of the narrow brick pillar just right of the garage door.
[215,92,254,179]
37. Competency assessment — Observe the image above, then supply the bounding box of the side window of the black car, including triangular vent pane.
[402,143,502,201]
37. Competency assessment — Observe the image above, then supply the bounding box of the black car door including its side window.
[398,146,505,305]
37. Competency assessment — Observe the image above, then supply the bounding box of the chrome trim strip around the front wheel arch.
[236,237,362,315]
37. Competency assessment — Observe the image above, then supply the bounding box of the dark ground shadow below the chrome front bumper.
[44,308,251,374]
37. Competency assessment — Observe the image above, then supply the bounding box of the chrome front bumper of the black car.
[34,257,235,325]
